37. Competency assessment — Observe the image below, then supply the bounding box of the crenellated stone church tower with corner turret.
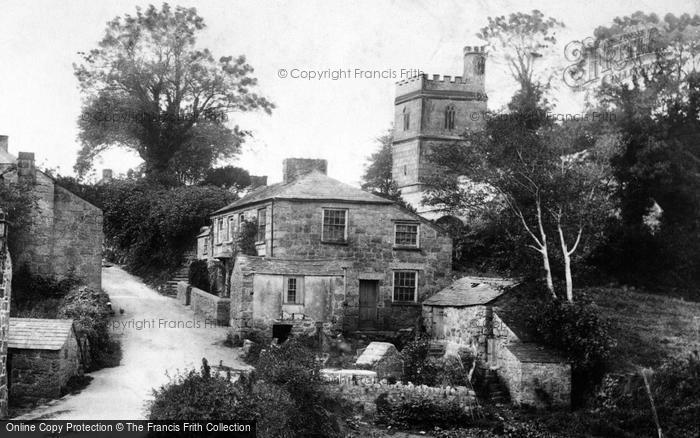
[391,46,486,219]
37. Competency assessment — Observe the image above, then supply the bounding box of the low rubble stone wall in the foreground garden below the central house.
[325,379,476,414]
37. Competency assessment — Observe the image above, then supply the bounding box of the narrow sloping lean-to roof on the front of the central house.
[236,255,351,275]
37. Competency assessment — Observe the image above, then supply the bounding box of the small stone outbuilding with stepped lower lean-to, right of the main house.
[423,277,571,407]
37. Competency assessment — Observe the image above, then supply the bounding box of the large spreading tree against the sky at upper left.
[74,3,273,184]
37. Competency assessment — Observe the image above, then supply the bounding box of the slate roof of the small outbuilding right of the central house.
[423,277,515,307]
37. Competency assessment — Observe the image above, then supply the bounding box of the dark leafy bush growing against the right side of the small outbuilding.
[523,295,616,404]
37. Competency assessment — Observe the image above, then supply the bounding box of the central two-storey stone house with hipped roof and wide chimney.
[198,159,452,334]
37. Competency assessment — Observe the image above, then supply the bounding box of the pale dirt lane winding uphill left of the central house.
[18,266,246,420]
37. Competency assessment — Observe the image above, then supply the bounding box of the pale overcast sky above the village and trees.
[0,0,700,184]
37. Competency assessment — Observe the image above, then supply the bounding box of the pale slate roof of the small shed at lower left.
[7,318,73,350]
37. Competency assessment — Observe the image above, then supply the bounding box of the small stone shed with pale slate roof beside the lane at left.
[8,318,83,404]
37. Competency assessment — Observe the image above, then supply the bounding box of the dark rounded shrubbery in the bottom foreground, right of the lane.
[149,338,344,438]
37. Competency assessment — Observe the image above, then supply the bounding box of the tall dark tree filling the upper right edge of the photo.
[585,12,700,289]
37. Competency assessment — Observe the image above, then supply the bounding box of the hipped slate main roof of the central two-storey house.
[212,171,392,215]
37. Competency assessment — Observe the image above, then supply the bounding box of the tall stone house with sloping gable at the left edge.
[0,136,103,290]
